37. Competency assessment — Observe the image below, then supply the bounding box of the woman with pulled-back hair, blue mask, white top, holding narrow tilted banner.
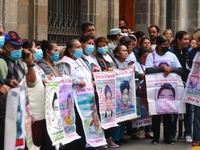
[56,39,95,150]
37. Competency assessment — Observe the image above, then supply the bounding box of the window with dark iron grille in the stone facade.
[48,0,80,45]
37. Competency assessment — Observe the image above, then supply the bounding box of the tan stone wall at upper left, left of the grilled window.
[0,0,48,40]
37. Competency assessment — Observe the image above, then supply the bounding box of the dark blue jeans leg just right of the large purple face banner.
[184,103,193,136]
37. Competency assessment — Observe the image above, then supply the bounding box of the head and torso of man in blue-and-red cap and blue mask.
[0,31,25,84]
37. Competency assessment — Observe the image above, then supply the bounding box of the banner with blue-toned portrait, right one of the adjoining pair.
[115,68,138,122]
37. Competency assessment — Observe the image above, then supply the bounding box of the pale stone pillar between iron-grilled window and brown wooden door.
[80,0,119,37]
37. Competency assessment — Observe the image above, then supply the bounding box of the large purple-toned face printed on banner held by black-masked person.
[156,83,178,114]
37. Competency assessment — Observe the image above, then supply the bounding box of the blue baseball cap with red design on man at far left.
[4,31,24,46]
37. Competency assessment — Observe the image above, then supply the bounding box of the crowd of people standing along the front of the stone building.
[0,20,200,150]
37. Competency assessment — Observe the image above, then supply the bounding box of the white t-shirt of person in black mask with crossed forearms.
[145,52,181,68]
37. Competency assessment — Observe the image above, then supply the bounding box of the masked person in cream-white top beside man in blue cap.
[22,39,53,150]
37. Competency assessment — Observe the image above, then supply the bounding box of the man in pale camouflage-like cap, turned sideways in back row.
[107,28,123,56]
